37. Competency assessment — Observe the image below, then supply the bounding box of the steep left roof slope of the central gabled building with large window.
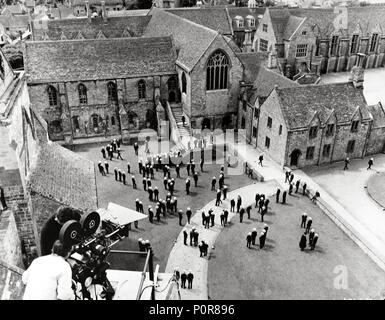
[144,8,219,70]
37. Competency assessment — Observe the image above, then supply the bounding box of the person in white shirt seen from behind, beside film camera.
[23,240,75,300]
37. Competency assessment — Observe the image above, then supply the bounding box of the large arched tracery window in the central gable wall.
[206,50,229,90]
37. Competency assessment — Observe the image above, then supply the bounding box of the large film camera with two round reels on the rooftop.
[59,211,129,300]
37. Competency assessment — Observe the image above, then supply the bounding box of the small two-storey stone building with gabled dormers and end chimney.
[258,67,373,167]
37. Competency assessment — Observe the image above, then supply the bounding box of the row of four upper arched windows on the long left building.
[47,80,146,107]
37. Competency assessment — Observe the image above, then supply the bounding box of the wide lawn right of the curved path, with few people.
[208,191,385,300]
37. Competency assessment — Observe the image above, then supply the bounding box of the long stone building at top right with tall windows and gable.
[253,6,385,78]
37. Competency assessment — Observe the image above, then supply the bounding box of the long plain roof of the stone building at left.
[25,37,176,83]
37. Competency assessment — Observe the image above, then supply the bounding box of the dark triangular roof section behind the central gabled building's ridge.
[166,7,232,35]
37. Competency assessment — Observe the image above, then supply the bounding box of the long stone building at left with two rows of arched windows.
[26,37,178,144]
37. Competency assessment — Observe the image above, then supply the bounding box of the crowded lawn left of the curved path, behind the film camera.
[74,144,251,272]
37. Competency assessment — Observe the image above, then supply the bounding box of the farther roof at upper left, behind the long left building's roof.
[33,16,151,40]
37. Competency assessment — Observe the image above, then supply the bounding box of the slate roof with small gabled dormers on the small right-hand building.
[274,82,372,129]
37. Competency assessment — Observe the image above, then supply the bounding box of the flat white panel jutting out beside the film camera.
[97,202,147,226]
